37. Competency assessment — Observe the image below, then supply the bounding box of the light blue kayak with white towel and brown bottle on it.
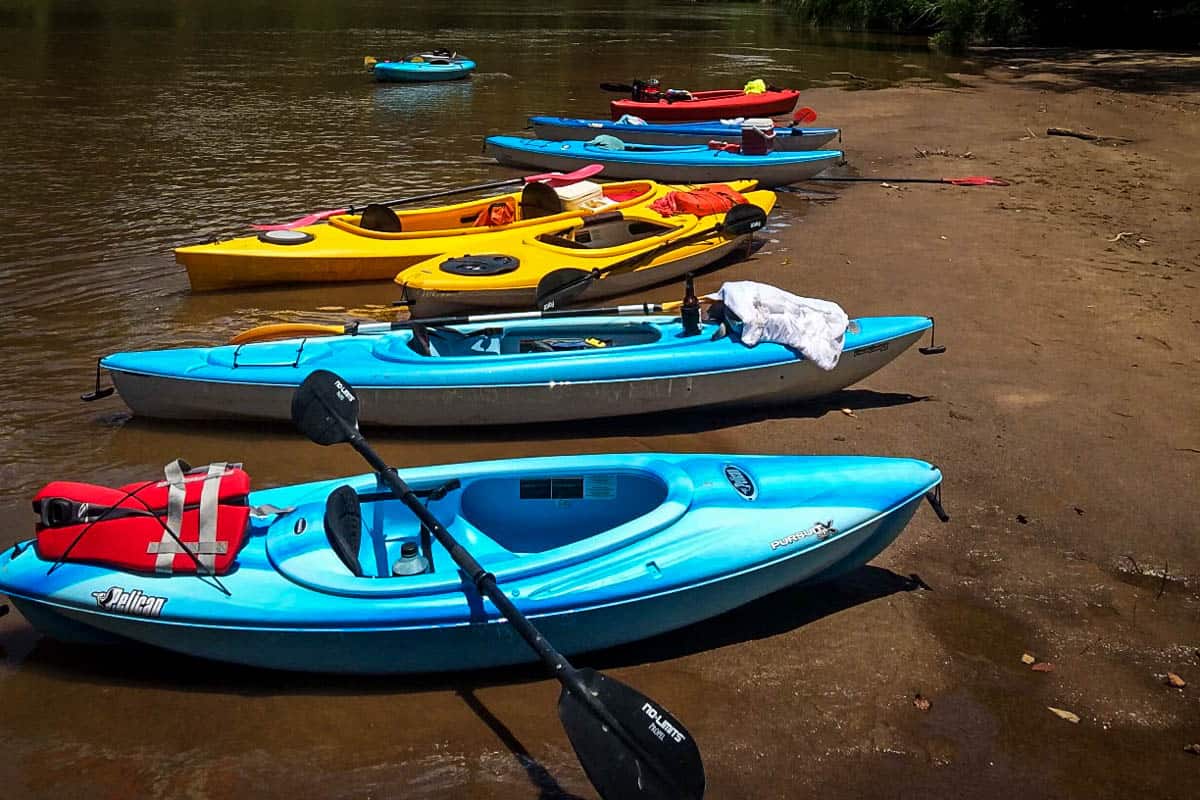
[101,305,931,426]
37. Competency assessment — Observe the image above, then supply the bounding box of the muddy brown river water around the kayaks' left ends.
[0,0,962,798]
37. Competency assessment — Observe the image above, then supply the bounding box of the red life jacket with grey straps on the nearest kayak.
[34,461,250,575]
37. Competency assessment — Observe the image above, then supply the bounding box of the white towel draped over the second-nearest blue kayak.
[708,281,850,371]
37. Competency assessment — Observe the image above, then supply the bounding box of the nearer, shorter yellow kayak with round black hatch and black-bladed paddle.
[396,181,775,317]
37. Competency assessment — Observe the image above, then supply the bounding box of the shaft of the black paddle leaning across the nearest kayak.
[334,424,674,796]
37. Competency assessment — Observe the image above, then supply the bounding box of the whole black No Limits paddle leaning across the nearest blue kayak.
[292,369,704,800]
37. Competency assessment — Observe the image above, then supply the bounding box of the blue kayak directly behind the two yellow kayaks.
[484,136,842,188]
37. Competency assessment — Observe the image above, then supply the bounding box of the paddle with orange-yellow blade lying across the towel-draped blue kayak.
[229,300,700,344]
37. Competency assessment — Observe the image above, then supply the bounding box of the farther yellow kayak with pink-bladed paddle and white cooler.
[175,181,729,291]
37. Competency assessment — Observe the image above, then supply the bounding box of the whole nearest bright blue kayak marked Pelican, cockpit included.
[0,452,942,673]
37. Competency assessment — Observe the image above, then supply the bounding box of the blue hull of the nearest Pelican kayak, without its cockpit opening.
[0,453,941,673]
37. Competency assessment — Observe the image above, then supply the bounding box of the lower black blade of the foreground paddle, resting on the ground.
[558,669,704,800]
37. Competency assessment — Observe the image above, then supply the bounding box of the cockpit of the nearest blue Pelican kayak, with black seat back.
[266,462,692,597]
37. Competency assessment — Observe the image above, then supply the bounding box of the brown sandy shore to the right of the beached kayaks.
[674,54,1200,798]
